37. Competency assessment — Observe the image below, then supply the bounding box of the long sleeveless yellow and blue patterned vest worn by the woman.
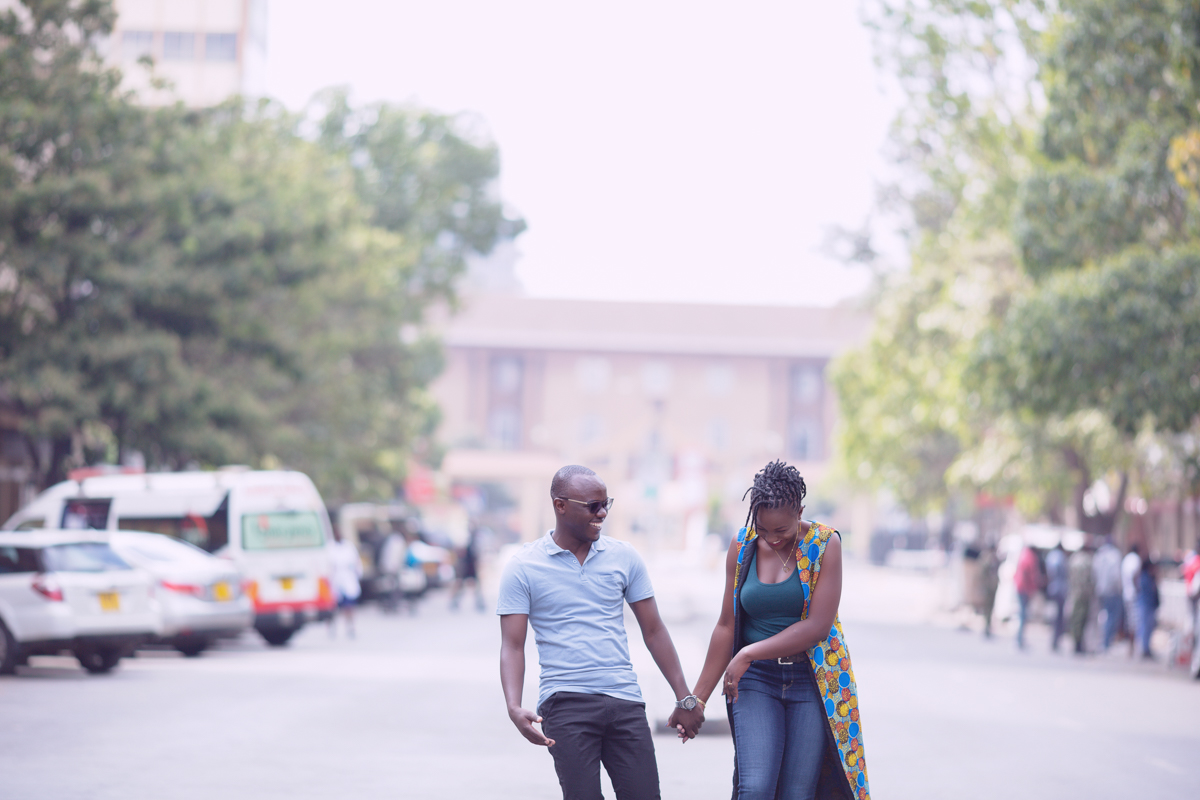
[731,522,871,800]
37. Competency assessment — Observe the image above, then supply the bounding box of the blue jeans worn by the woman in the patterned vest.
[731,656,829,800]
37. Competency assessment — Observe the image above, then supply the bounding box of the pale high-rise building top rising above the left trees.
[108,0,266,107]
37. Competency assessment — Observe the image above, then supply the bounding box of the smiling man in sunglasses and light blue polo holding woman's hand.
[497,465,704,800]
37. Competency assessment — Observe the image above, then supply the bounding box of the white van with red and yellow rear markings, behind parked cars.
[4,469,336,645]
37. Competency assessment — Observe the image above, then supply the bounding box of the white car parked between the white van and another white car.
[108,530,254,656]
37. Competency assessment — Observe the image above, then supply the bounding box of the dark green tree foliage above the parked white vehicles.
[0,0,522,498]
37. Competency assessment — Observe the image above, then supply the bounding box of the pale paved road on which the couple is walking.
[0,554,1200,800]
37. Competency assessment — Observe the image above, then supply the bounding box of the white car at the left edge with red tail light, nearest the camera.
[0,530,160,673]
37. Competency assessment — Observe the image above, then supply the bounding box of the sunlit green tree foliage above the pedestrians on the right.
[839,0,1200,533]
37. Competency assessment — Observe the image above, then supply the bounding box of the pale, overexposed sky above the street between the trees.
[266,0,893,306]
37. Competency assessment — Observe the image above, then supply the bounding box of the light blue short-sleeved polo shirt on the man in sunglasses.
[496,531,654,705]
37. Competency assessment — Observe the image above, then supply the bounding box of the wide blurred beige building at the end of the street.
[433,294,869,546]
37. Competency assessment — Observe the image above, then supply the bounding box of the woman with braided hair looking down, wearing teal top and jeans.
[694,461,870,800]
